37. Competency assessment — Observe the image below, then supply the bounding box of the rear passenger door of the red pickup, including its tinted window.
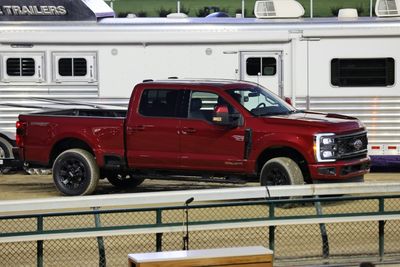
[126,88,186,169]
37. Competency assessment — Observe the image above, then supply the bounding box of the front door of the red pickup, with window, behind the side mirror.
[180,91,245,172]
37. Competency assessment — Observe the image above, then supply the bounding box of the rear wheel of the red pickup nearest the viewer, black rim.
[53,149,100,196]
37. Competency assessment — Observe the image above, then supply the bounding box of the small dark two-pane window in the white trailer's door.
[246,57,276,76]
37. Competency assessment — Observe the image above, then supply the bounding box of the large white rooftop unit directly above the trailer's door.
[254,0,304,19]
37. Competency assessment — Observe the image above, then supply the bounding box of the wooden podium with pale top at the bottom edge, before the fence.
[128,246,273,267]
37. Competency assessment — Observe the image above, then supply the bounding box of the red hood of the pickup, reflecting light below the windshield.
[265,111,365,133]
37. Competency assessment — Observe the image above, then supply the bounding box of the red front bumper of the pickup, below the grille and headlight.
[309,157,371,181]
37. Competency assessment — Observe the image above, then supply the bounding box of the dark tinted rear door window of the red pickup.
[139,89,187,117]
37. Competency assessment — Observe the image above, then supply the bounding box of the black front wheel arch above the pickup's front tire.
[256,146,312,183]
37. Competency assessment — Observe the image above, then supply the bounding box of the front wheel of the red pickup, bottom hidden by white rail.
[260,157,304,186]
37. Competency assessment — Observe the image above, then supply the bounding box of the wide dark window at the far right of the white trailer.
[331,58,394,87]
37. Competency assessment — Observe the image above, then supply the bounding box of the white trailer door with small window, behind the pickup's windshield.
[240,51,283,97]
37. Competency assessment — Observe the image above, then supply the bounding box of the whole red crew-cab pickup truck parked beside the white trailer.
[17,80,370,195]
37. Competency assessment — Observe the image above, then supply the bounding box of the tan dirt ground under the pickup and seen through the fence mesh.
[0,173,400,266]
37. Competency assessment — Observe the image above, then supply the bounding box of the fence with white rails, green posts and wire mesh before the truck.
[0,183,400,266]
